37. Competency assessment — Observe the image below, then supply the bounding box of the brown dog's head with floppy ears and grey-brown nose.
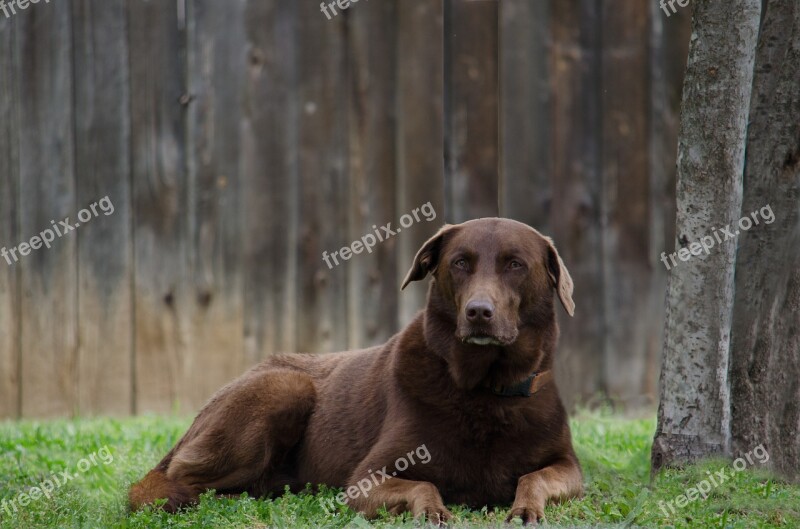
[403,218,575,386]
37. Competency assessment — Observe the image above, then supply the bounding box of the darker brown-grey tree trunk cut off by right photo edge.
[730,0,800,478]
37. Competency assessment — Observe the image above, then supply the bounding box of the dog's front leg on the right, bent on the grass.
[506,457,583,524]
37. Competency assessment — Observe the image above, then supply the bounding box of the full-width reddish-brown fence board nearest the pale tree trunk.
[601,2,663,403]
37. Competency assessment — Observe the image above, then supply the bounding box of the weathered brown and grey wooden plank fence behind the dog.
[0,0,688,418]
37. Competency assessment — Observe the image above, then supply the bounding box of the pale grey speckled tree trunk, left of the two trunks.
[652,0,761,470]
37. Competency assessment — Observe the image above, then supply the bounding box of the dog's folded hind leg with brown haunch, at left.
[128,369,316,512]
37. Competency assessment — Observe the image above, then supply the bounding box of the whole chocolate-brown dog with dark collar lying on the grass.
[129,218,583,523]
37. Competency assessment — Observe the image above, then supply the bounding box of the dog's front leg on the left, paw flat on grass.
[346,474,453,525]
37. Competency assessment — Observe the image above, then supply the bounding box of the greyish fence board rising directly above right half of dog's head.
[500,0,553,233]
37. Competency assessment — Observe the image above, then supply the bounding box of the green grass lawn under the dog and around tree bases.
[0,413,800,529]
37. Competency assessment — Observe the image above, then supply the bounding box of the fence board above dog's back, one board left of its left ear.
[341,2,406,347]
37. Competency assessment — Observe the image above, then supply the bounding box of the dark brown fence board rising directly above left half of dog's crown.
[444,0,500,222]
